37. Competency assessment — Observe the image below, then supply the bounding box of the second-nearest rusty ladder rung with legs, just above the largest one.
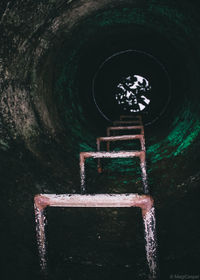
[80,151,149,194]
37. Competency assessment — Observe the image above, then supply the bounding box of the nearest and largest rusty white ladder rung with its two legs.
[34,194,158,279]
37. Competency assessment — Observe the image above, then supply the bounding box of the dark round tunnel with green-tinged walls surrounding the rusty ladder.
[0,0,200,280]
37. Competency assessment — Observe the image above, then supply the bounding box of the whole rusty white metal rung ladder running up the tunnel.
[34,115,158,279]
